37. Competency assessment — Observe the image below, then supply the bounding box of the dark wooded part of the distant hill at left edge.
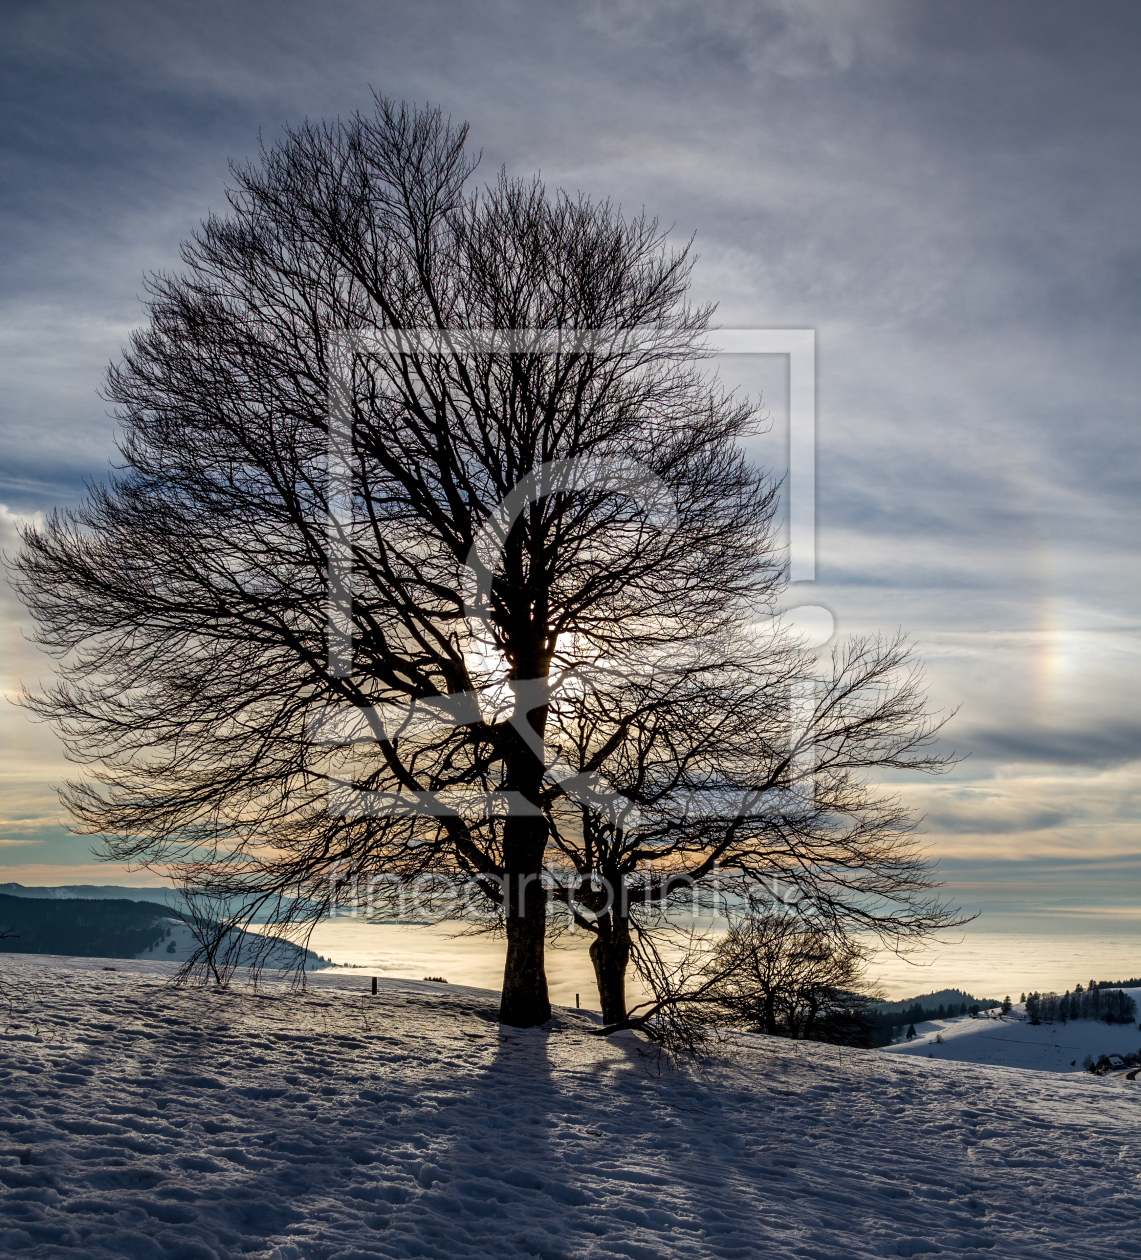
[0,893,176,958]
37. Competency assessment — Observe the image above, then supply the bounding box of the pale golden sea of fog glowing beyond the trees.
[299,919,1141,1009]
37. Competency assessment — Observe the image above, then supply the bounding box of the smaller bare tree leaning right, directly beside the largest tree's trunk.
[548,629,962,1027]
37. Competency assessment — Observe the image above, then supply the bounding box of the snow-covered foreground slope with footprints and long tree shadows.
[0,955,1141,1260]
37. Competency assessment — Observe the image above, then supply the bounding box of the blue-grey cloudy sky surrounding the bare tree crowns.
[0,0,1141,932]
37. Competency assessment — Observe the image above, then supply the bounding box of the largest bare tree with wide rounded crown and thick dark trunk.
[8,98,781,1026]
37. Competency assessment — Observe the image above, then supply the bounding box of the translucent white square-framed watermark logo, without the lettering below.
[310,329,834,825]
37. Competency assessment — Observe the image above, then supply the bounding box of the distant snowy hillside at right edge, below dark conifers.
[884,989,1141,1072]
